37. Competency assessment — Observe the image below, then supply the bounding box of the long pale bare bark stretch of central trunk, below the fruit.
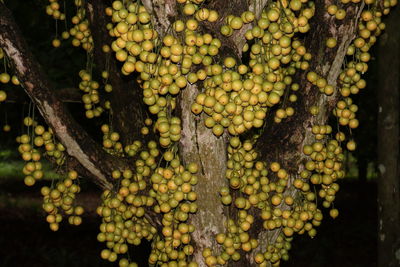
[179,85,227,267]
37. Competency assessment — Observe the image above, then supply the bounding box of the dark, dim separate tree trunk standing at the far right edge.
[378,4,400,267]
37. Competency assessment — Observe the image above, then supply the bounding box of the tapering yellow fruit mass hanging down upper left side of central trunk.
[106,1,188,147]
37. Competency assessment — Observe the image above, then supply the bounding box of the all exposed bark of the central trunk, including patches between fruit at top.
[147,0,268,267]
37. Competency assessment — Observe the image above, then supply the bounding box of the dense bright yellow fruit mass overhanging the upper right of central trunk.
[193,3,314,136]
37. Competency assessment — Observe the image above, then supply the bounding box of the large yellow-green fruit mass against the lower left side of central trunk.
[97,138,198,266]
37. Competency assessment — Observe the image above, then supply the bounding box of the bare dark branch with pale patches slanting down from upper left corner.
[0,3,131,189]
